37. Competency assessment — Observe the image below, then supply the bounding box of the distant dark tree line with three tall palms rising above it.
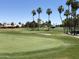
[0,7,52,31]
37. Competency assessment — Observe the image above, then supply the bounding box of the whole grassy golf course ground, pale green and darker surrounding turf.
[0,28,79,59]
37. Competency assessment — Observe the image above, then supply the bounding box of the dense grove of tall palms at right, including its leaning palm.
[58,0,79,35]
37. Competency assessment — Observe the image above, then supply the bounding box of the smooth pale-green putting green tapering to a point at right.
[0,33,66,53]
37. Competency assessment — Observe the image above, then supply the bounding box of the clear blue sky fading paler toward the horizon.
[0,0,78,24]
